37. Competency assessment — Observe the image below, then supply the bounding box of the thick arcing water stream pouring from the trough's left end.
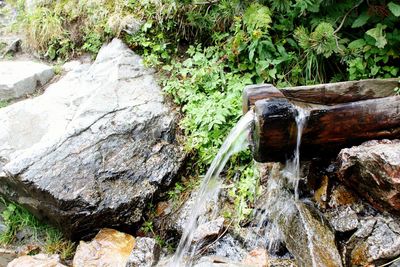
[170,110,254,267]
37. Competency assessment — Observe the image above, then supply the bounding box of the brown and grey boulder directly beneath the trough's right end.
[337,140,400,214]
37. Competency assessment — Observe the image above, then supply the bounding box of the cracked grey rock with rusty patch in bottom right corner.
[346,216,400,266]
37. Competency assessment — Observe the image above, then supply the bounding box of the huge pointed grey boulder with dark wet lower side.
[0,39,184,239]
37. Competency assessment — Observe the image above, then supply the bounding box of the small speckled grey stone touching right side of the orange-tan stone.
[126,237,160,267]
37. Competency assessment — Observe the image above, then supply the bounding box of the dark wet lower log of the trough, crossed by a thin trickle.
[252,96,400,162]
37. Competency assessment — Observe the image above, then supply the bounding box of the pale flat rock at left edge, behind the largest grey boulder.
[0,61,54,100]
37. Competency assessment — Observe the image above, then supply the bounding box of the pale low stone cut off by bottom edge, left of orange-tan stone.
[7,254,66,267]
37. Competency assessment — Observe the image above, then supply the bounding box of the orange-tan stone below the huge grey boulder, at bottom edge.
[73,228,135,267]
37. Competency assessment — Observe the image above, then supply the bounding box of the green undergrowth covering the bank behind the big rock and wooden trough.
[3,0,400,230]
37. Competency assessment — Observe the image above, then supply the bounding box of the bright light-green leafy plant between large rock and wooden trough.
[163,46,252,168]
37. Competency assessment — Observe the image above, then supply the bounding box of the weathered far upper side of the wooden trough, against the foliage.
[243,78,399,112]
